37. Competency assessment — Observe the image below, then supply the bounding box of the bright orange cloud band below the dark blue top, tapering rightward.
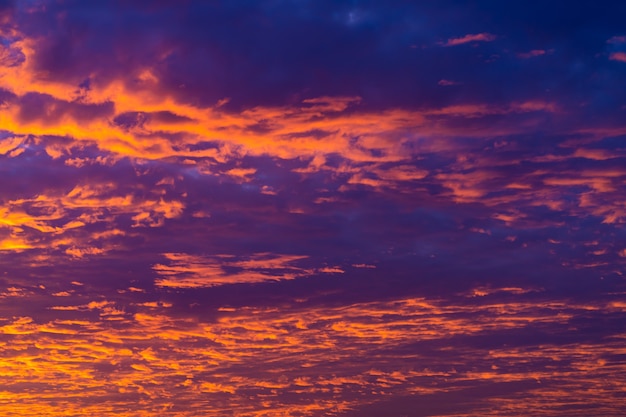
[0,34,555,178]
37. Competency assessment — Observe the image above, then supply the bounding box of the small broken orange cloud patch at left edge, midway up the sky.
[0,175,185,254]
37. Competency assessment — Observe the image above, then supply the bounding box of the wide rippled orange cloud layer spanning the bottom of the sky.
[0,292,624,417]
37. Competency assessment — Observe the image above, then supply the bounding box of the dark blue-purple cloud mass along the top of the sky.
[9,1,624,115]
